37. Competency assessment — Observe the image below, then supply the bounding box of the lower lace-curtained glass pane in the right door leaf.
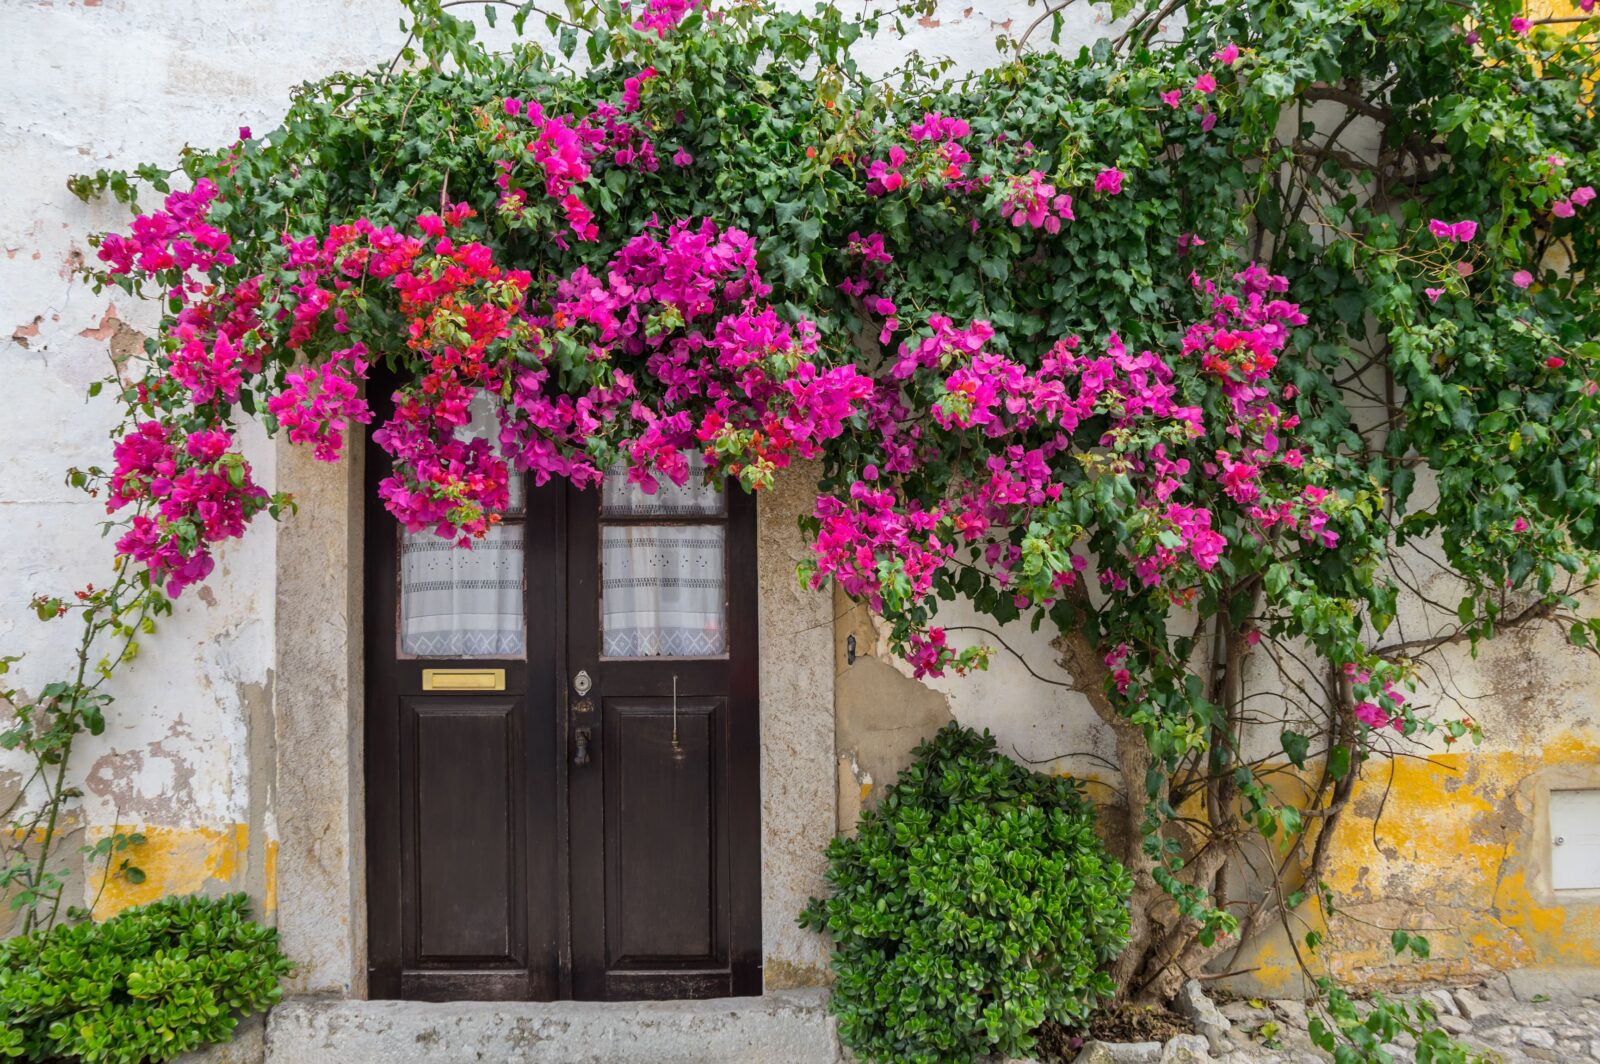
[600,525,728,658]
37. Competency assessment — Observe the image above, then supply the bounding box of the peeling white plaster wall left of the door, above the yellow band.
[0,0,398,889]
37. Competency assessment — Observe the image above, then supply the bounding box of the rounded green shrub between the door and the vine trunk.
[800,723,1131,1064]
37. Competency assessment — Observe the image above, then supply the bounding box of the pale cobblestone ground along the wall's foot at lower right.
[1209,976,1600,1064]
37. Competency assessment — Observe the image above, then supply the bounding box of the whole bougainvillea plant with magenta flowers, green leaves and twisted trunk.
[12,0,1600,1053]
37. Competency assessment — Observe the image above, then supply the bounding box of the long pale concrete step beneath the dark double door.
[266,990,842,1064]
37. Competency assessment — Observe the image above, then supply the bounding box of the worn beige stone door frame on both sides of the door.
[270,440,837,998]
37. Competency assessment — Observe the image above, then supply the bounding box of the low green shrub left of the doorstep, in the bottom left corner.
[0,894,291,1064]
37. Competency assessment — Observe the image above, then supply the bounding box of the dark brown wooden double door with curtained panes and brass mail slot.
[365,412,762,1000]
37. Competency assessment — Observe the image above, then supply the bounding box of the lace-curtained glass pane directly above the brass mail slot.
[400,522,523,658]
